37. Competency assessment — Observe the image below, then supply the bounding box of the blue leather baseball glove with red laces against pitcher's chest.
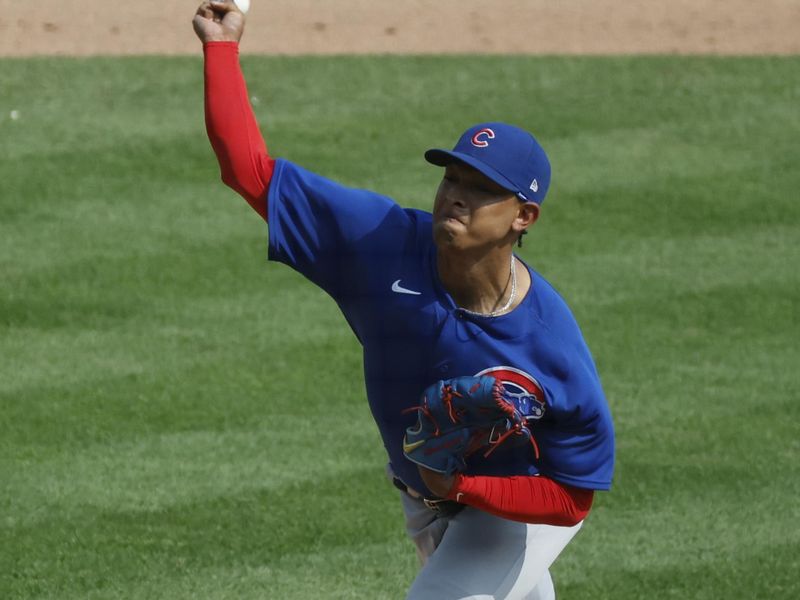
[403,375,539,475]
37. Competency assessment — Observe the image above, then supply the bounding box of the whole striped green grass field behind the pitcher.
[0,57,800,600]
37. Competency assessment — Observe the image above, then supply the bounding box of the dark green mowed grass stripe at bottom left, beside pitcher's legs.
[4,469,409,597]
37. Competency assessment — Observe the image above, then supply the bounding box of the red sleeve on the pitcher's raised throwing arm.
[203,42,275,220]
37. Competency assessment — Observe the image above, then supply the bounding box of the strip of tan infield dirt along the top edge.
[0,0,800,56]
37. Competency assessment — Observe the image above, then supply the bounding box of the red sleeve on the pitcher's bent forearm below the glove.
[447,475,594,527]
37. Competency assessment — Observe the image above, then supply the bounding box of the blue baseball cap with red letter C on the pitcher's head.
[425,123,550,204]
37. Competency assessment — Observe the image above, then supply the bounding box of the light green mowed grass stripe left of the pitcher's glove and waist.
[5,418,382,529]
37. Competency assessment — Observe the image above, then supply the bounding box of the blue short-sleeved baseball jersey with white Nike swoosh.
[268,160,614,493]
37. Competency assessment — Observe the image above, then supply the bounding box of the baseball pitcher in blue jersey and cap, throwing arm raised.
[193,0,614,600]
